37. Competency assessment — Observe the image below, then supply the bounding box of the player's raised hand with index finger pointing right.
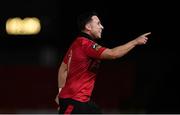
[135,32,151,45]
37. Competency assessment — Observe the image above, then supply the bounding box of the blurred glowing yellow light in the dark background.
[6,17,41,35]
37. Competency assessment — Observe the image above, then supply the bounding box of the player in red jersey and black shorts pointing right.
[55,12,150,114]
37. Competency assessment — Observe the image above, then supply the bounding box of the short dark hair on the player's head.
[77,11,98,31]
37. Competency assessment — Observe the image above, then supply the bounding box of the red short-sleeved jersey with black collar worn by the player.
[59,34,106,102]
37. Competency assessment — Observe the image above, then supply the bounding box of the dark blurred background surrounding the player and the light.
[0,0,180,113]
